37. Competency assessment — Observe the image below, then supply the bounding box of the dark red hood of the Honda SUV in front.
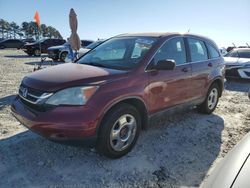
[22,63,127,92]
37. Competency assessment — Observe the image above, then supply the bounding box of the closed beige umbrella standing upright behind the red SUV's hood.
[69,8,81,51]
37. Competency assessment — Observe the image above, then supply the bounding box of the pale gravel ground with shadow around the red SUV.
[0,50,250,187]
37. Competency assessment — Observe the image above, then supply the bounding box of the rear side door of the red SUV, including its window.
[186,37,213,100]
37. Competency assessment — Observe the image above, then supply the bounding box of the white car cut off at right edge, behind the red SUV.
[224,48,250,79]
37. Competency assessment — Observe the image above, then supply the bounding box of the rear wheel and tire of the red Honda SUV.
[197,83,220,114]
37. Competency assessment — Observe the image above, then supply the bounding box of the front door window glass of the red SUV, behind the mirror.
[153,37,186,65]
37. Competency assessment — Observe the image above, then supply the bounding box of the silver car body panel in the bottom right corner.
[201,133,250,188]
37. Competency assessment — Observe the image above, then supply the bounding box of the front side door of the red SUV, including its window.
[146,37,191,113]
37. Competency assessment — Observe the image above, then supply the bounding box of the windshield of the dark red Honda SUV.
[77,37,156,70]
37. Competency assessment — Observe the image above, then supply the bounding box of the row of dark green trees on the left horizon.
[0,19,62,40]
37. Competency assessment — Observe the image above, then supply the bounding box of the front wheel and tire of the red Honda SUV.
[96,103,141,158]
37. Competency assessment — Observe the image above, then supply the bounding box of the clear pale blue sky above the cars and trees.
[0,0,250,47]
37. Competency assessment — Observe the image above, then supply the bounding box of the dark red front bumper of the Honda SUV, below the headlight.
[11,96,98,141]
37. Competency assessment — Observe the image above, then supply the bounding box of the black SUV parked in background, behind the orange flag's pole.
[23,39,66,56]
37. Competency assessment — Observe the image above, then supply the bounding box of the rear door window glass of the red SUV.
[188,38,208,62]
